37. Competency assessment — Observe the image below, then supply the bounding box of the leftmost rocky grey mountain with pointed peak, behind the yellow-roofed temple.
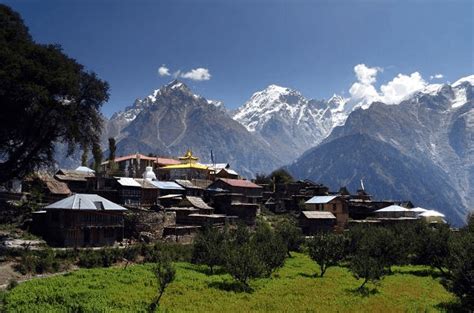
[104,81,283,177]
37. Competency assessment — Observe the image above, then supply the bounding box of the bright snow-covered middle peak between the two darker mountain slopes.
[233,85,348,161]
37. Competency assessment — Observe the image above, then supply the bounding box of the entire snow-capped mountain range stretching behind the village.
[54,76,474,224]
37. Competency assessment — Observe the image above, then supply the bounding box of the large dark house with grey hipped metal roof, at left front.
[33,194,126,247]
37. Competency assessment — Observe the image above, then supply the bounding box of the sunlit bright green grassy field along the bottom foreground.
[3,254,454,313]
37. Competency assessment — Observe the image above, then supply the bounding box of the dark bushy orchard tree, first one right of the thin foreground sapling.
[192,225,226,274]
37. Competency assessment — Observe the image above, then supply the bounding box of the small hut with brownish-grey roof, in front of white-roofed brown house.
[299,211,336,235]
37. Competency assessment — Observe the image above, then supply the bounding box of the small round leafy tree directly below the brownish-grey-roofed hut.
[308,233,344,277]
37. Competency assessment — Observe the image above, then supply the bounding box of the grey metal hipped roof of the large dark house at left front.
[45,193,127,211]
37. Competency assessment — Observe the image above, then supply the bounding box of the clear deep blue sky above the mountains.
[3,0,474,116]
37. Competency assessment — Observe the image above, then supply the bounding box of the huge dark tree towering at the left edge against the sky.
[0,5,109,183]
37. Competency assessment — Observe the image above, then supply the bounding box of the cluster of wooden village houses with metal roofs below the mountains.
[1,150,445,247]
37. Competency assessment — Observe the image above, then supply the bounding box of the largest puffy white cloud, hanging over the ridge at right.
[349,64,427,108]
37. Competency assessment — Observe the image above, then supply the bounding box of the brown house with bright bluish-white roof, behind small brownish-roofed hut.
[305,195,349,231]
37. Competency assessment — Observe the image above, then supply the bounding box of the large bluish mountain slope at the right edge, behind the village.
[288,76,474,223]
